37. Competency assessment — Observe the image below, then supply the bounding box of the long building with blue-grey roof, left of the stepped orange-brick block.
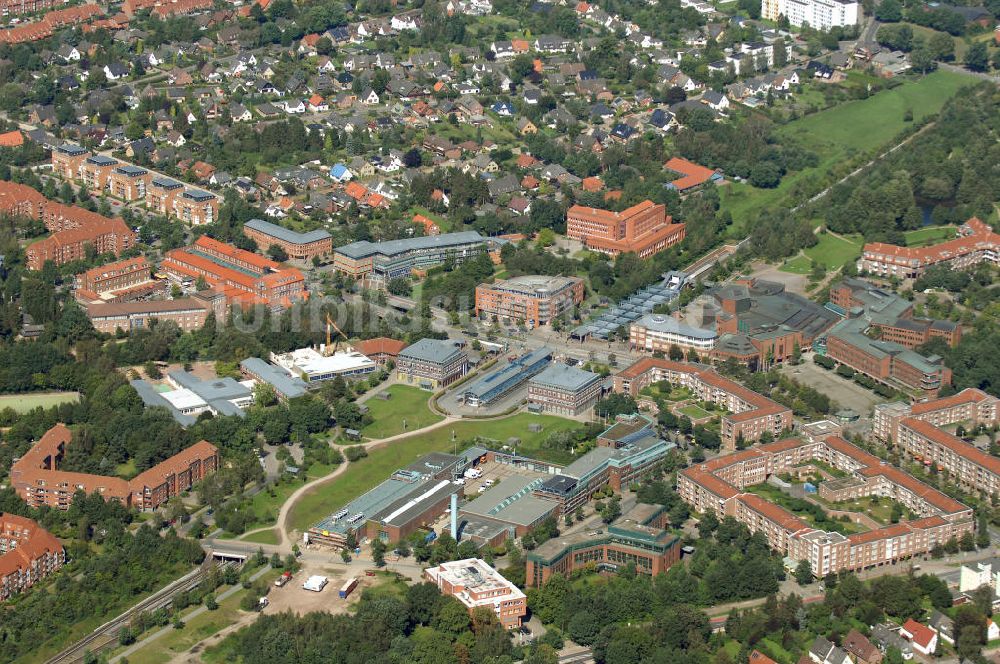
[333,231,487,284]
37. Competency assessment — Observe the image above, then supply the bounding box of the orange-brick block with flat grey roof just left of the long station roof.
[476,275,583,327]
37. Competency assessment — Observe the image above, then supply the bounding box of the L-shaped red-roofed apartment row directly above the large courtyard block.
[614,358,792,449]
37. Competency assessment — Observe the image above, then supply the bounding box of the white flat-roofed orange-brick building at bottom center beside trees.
[424,558,528,629]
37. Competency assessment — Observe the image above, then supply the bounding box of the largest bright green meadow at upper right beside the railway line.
[721,71,975,235]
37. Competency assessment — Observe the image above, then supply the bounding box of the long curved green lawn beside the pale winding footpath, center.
[290,413,579,531]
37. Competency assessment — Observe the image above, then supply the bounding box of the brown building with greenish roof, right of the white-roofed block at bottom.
[525,503,681,588]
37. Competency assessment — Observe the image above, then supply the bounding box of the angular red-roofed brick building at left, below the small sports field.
[10,424,219,510]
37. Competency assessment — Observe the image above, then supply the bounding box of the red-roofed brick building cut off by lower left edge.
[0,512,66,602]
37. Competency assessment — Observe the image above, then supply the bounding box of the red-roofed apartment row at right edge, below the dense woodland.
[858,217,1000,279]
